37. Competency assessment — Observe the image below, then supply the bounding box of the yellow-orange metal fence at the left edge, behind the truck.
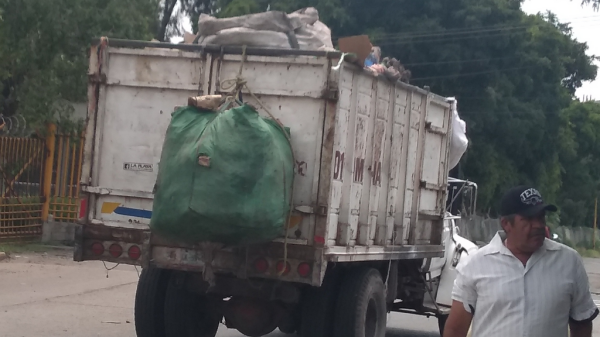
[0,126,84,241]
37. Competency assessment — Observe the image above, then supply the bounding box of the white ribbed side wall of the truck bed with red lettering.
[326,64,451,255]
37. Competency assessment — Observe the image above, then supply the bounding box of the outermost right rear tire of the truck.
[333,268,387,337]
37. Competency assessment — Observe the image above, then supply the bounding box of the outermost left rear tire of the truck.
[134,266,169,337]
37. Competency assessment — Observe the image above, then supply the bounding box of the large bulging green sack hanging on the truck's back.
[150,105,294,245]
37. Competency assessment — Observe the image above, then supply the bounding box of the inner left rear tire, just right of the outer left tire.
[164,274,222,337]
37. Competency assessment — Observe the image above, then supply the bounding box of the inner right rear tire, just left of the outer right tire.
[299,267,341,337]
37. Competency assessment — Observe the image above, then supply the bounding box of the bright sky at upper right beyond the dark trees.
[522,0,600,100]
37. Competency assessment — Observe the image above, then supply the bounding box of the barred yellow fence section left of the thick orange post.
[0,136,47,241]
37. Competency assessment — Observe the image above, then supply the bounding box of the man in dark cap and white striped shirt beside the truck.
[443,186,598,337]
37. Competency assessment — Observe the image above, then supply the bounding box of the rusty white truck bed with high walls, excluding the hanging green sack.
[76,39,451,284]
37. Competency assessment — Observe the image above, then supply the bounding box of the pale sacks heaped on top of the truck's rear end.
[197,7,335,51]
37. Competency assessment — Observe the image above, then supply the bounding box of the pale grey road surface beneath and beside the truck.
[0,251,600,337]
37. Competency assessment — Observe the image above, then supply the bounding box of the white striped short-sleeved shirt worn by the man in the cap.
[452,232,598,337]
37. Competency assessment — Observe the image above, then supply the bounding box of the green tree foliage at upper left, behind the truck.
[0,0,158,128]
